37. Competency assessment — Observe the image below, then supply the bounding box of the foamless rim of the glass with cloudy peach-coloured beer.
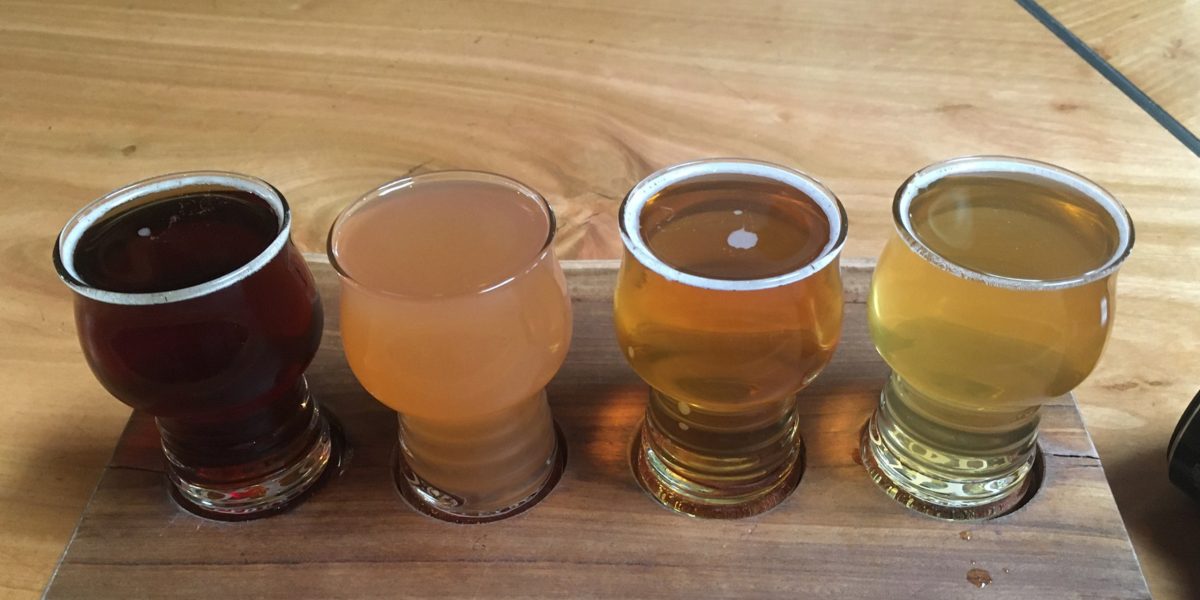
[325,169,558,301]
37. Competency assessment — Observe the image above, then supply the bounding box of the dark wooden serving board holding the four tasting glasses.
[46,256,1150,600]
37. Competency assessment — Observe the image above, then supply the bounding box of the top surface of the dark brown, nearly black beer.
[74,190,280,293]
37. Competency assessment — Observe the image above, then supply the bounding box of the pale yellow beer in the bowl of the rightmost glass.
[870,178,1117,410]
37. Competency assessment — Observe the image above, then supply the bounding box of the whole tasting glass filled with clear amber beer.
[614,160,846,518]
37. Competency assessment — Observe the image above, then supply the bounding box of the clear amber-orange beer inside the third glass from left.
[614,177,842,511]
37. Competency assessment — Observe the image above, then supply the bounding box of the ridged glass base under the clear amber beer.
[631,388,804,518]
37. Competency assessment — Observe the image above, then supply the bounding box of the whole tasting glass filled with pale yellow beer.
[862,156,1133,520]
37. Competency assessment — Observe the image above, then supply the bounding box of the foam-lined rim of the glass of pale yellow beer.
[892,155,1134,290]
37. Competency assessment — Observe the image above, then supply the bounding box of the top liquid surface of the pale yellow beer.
[910,175,1118,281]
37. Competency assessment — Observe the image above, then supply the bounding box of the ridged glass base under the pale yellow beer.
[860,373,1038,521]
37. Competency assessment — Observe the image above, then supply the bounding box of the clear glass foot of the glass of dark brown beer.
[168,397,347,521]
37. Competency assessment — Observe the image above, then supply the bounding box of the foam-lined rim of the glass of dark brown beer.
[54,170,292,306]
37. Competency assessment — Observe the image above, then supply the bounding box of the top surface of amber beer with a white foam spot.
[641,180,829,281]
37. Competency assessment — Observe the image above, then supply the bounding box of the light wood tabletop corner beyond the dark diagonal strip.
[1039,0,1200,133]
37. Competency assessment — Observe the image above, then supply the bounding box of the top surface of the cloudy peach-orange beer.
[332,181,550,296]
